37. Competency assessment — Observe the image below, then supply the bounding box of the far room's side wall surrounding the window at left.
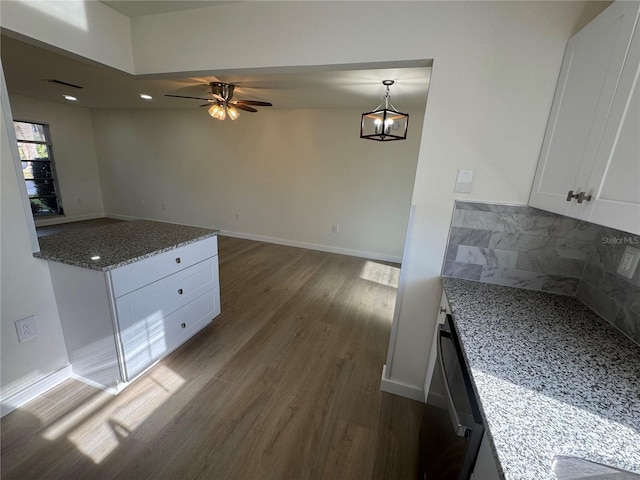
[9,94,104,225]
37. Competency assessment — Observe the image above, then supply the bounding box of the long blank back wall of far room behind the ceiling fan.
[92,108,423,261]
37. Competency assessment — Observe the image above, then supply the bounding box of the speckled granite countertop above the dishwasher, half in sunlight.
[443,278,640,480]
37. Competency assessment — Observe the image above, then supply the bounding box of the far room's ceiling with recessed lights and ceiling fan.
[0,31,430,111]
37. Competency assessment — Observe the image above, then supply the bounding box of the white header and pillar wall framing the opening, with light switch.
[1,1,603,398]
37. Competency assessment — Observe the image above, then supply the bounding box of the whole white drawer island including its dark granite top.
[34,220,220,393]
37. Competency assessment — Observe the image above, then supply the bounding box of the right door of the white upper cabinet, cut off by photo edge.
[586,27,640,234]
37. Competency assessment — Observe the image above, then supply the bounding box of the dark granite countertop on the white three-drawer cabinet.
[33,220,218,271]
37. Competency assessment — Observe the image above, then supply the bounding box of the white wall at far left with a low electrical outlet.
[0,73,69,413]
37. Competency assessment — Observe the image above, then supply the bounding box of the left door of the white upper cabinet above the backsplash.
[529,2,638,214]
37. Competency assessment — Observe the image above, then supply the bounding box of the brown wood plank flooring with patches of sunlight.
[1,237,422,480]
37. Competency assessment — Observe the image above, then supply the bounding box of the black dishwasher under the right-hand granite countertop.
[418,315,484,480]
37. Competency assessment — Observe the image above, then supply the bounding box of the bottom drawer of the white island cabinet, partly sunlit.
[123,287,220,381]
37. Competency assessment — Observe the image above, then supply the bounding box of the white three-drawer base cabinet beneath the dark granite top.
[50,236,220,392]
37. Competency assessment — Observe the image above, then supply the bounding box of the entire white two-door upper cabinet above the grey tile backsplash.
[529,2,640,234]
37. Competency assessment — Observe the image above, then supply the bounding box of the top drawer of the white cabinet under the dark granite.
[110,236,218,298]
